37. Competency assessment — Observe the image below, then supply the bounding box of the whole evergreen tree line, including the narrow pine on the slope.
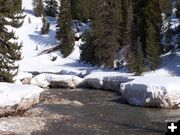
[35,0,179,75]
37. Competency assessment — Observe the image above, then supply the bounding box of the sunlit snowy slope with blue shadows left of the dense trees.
[16,0,91,73]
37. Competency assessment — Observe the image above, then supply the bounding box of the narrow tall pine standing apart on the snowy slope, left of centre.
[57,0,74,57]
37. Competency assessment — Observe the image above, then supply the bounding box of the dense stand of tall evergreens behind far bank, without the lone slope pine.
[77,0,176,75]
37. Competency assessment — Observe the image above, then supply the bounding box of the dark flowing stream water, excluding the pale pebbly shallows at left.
[32,89,180,135]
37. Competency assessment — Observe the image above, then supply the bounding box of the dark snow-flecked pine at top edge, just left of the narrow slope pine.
[45,0,58,17]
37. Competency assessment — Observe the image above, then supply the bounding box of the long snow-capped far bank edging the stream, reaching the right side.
[13,71,180,108]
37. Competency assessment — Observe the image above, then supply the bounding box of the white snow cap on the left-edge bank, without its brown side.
[0,83,43,108]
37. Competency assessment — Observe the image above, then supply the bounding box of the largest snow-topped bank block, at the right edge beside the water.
[120,77,180,108]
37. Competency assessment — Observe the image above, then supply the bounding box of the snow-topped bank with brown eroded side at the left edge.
[0,83,43,117]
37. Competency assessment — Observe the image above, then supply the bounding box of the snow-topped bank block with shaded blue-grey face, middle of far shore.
[84,72,132,91]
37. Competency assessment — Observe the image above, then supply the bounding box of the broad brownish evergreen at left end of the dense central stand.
[81,0,122,68]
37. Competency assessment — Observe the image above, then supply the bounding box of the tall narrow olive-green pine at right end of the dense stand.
[145,0,161,70]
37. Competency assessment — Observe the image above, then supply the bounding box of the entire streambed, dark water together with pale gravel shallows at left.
[0,89,180,135]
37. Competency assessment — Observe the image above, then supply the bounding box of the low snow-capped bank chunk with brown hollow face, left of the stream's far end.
[31,74,83,88]
